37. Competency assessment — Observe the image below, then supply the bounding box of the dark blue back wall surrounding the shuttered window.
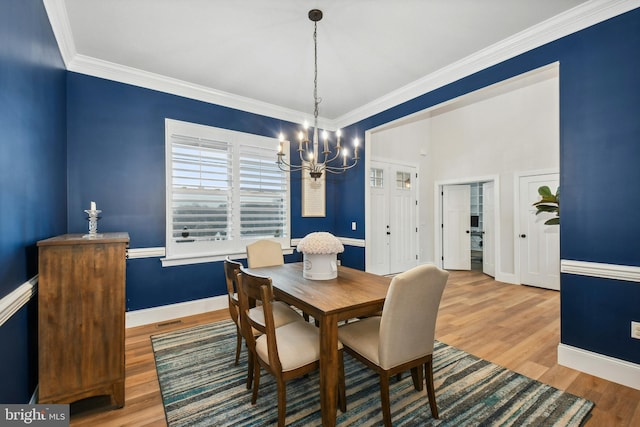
[67,73,362,310]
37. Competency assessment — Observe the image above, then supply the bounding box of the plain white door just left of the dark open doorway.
[442,184,471,270]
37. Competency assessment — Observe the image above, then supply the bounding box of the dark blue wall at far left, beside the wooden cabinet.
[0,0,67,403]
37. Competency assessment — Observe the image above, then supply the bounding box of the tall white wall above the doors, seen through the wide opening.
[370,64,560,279]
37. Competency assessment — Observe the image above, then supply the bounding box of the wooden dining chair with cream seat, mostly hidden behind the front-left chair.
[224,257,304,389]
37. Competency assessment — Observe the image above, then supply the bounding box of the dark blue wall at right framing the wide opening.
[337,9,640,363]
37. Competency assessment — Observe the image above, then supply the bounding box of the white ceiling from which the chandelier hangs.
[44,0,636,127]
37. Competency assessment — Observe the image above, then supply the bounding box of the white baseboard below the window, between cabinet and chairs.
[125,294,228,328]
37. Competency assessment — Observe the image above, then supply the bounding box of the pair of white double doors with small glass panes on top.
[366,161,418,274]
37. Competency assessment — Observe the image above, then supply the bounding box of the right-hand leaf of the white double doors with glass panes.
[389,165,418,273]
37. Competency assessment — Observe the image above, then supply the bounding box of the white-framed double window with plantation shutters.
[163,119,290,265]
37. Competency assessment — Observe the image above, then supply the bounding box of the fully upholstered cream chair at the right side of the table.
[338,265,449,426]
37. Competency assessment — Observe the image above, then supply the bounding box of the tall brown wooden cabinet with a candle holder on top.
[38,233,129,407]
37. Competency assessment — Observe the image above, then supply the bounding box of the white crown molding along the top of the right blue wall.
[335,0,640,128]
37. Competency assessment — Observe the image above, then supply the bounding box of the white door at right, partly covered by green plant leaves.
[518,174,560,290]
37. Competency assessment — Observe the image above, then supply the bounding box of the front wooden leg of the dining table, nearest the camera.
[320,315,339,427]
